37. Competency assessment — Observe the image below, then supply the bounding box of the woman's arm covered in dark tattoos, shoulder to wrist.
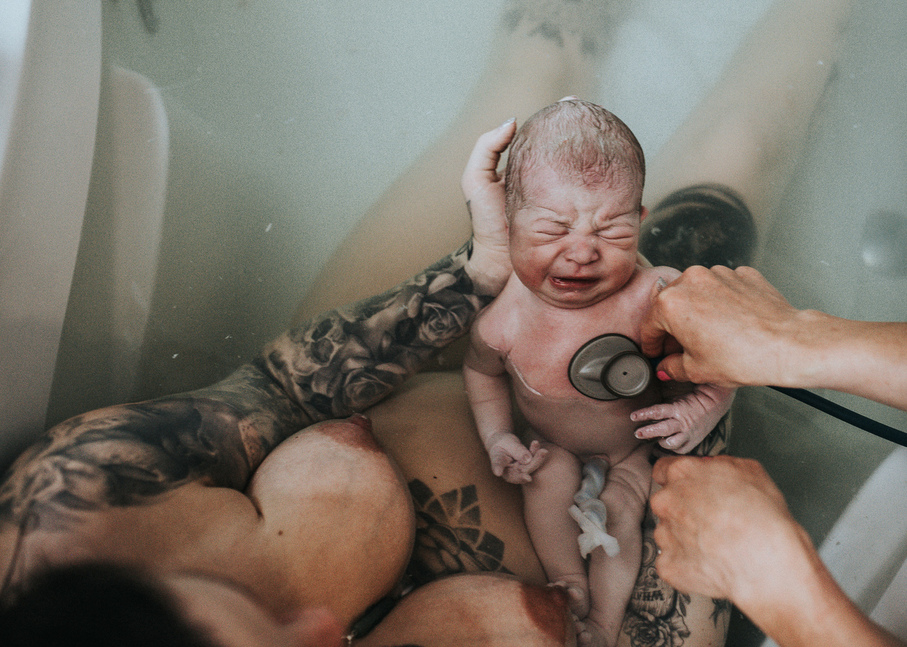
[0,239,493,531]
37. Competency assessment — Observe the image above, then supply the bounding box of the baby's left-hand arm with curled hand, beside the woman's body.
[463,326,548,484]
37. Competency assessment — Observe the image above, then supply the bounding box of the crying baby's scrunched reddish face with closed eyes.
[510,167,645,308]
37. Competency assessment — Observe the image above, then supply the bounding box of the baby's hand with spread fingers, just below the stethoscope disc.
[630,384,735,454]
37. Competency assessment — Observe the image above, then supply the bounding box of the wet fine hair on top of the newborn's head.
[504,99,646,220]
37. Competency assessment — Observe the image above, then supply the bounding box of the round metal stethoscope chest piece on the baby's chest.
[567,334,653,400]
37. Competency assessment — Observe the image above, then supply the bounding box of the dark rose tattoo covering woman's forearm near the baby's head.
[262,245,492,420]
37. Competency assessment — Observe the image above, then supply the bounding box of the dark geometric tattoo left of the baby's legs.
[409,479,510,585]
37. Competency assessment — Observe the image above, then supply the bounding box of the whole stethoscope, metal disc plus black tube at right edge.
[567,334,907,447]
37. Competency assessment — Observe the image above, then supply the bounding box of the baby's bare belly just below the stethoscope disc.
[514,380,658,464]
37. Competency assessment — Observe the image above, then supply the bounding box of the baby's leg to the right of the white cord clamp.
[577,445,652,647]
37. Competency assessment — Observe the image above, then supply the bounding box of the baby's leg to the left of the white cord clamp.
[523,443,592,618]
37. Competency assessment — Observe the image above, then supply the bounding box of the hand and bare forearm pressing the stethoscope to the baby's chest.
[642,267,907,410]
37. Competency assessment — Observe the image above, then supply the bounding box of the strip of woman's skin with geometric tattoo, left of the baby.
[367,371,546,584]
